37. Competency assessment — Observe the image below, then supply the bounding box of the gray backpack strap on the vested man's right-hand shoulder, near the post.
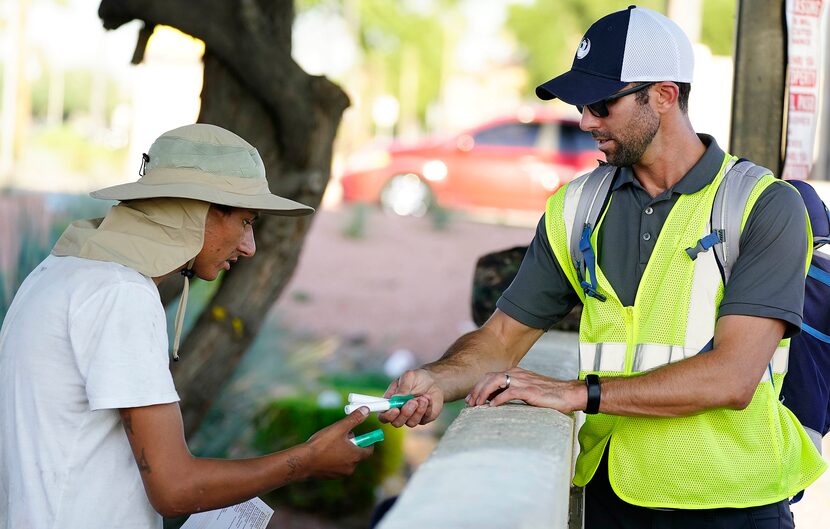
[712,160,772,285]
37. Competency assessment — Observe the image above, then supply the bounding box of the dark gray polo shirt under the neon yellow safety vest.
[496,134,807,336]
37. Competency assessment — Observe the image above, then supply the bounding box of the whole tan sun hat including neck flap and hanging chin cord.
[52,123,314,360]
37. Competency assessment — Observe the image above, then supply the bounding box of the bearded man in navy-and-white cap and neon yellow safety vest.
[381,6,827,529]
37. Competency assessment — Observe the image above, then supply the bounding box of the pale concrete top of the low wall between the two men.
[379,332,577,529]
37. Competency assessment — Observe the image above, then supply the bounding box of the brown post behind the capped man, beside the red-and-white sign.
[730,0,787,175]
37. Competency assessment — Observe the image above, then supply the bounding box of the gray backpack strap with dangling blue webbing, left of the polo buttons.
[568,164,617,301]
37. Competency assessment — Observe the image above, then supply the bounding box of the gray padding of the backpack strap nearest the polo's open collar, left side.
[568,164,617,300]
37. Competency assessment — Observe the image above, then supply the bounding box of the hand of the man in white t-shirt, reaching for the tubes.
[305,407,374,479]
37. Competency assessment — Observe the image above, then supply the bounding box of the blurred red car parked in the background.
[341,109,604,216]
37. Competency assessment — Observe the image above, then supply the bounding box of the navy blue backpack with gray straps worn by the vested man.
[568,159,830,456]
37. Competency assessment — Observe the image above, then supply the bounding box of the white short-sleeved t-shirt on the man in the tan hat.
[0,256,179,529]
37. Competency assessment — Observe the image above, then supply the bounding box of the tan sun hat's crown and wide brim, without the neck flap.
[90,123,314,217]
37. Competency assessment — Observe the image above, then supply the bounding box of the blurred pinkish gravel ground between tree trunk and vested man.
[274,206,535,361]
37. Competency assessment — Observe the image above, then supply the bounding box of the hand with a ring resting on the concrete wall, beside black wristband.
[464,367,588,413]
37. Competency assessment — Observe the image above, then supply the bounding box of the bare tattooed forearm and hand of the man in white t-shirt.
[119,403,372,517]
